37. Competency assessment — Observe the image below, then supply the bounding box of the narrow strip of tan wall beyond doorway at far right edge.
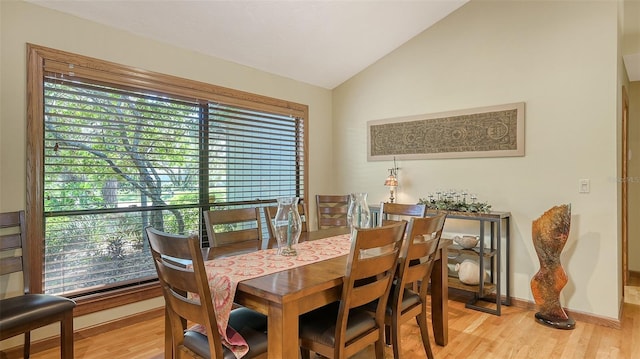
[627,81,640,272]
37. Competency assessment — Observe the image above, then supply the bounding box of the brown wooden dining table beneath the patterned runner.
[205,228,451,359]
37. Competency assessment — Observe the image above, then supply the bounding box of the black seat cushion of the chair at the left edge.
[0,294,76,332]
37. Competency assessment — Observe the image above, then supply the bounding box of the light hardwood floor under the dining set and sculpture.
[26,288,640,359]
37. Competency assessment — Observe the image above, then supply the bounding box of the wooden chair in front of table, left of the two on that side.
[299,221,407,359]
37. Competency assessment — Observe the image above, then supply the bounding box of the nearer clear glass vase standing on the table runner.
[273,197,302,256]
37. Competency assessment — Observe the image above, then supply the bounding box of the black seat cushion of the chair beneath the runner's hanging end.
[184,308,267,359]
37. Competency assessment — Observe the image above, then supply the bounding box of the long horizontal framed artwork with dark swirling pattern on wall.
[367,102,524,161]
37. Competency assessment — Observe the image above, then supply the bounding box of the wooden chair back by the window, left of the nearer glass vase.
[204,207,264,255]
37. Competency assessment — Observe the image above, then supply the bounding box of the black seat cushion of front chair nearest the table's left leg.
[300,302,376,346]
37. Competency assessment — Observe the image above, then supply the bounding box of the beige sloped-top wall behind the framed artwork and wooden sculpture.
[333,1,621,319]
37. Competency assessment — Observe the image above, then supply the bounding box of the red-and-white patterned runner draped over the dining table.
[190,234,351,358]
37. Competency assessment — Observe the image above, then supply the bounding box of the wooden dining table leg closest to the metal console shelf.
[431,247,449,346]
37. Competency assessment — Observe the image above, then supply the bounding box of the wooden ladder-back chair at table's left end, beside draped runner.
[145,227,267,359]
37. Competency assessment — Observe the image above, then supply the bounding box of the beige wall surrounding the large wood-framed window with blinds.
[0,1,333,348]
